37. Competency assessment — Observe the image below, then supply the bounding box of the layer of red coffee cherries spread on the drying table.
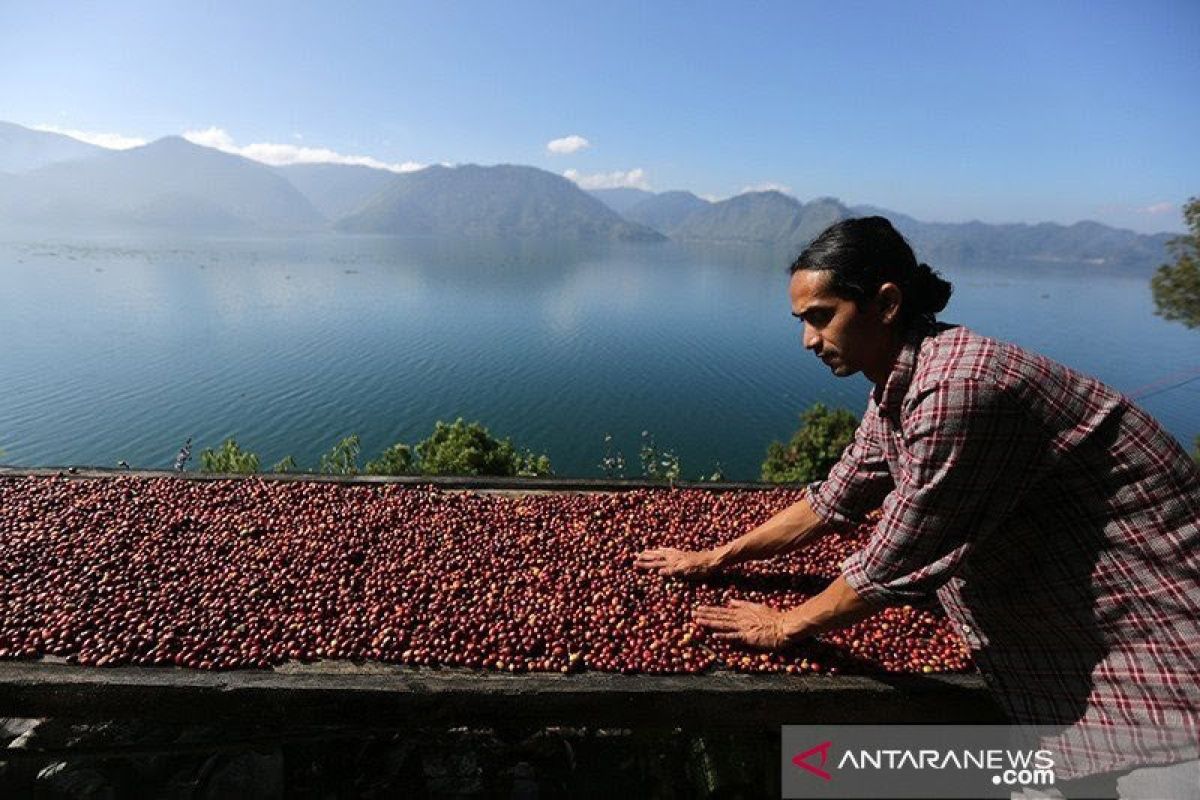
[0,476,971,674]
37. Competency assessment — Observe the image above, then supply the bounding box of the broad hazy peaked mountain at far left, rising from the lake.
[0,137,325,233]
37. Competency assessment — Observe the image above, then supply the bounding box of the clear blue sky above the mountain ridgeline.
[0,0,1200,231]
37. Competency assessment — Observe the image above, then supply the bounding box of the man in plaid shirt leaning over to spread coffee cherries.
[636,217,1200,796]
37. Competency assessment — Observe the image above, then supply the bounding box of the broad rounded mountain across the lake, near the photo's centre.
[337,164,662,241]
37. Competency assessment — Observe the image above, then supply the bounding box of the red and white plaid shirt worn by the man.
[809,325,1200,777]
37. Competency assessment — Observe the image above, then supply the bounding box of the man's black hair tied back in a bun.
[790,217,952,327]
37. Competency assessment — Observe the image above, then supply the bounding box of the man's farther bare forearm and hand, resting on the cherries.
[634,495,833,577]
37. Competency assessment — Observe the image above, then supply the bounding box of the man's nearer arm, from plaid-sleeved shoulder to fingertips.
[696,379,1049,648]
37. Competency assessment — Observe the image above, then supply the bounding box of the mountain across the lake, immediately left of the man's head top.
[665,192,853,248]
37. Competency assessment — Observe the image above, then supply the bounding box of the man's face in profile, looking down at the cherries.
[788,270,889,380]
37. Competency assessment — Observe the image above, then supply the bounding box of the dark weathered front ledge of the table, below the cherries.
[0,658,1003,728]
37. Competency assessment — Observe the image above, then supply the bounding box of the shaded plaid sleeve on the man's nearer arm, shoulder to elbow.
[842,380,1039,606]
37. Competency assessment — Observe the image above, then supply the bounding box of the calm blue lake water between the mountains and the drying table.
[0,237,1200,479]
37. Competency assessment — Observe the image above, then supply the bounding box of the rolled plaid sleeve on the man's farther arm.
[808,397,894,525]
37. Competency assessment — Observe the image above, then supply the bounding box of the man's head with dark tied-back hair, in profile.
[788,217,950,383]
